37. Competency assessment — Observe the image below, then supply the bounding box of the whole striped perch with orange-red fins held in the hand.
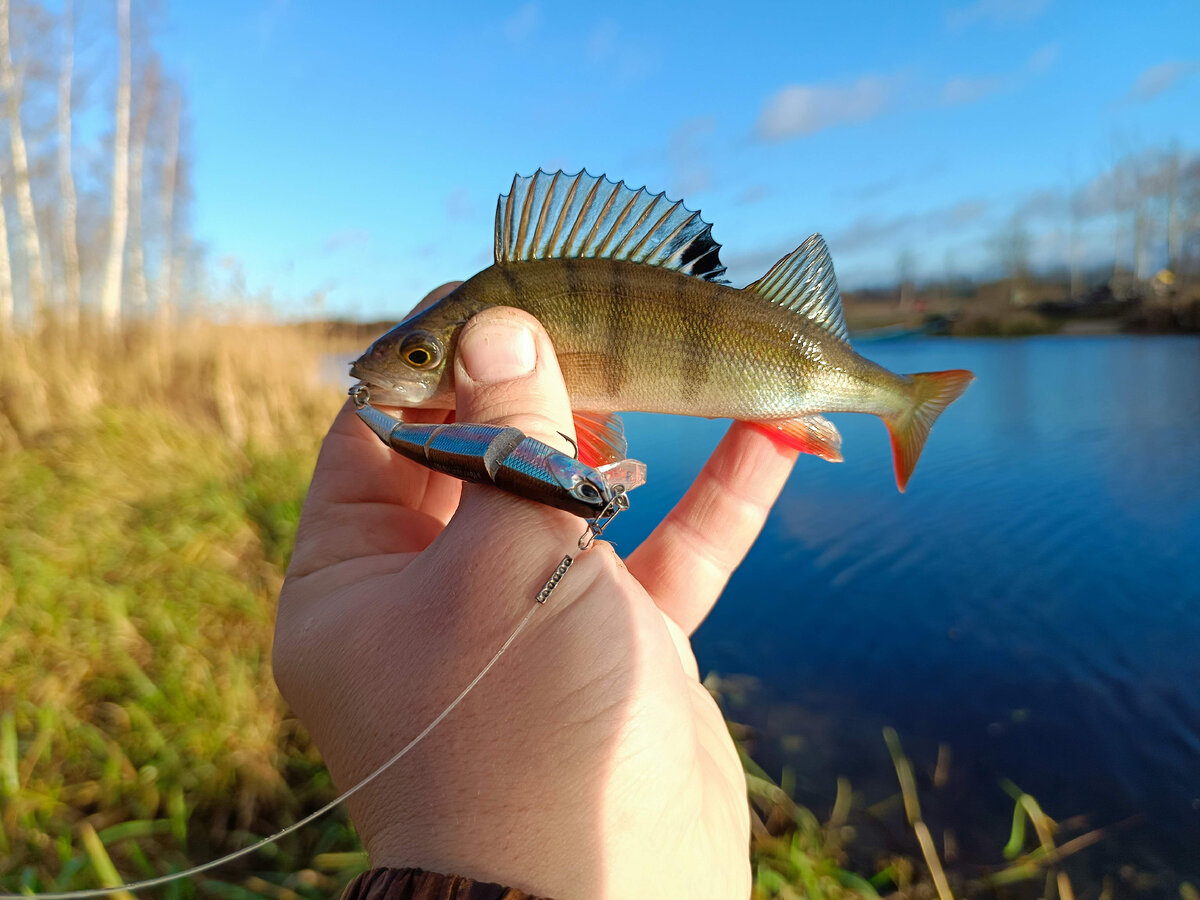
[350,169,973,491]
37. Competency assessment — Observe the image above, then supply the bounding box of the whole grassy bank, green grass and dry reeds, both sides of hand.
[0,322,1156,898]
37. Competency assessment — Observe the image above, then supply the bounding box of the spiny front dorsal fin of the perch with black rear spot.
[496,169,725,281]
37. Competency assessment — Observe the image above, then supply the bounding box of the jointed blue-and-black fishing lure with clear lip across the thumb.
[352,391,646,518]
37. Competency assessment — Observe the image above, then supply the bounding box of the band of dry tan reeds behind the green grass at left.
[0,319,352,451]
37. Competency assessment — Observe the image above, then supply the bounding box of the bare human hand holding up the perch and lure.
[274,289,796,899]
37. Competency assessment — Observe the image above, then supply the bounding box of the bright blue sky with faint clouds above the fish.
[156,0,1200,319]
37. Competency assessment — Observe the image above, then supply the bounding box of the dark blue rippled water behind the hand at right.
[616,337,1200,878]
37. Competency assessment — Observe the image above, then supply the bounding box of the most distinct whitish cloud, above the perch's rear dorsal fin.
[757,76,900,140]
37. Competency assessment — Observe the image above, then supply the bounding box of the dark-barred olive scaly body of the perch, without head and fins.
[468,259,905,419]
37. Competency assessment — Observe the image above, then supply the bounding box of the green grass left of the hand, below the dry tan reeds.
[0,403,361,896]
